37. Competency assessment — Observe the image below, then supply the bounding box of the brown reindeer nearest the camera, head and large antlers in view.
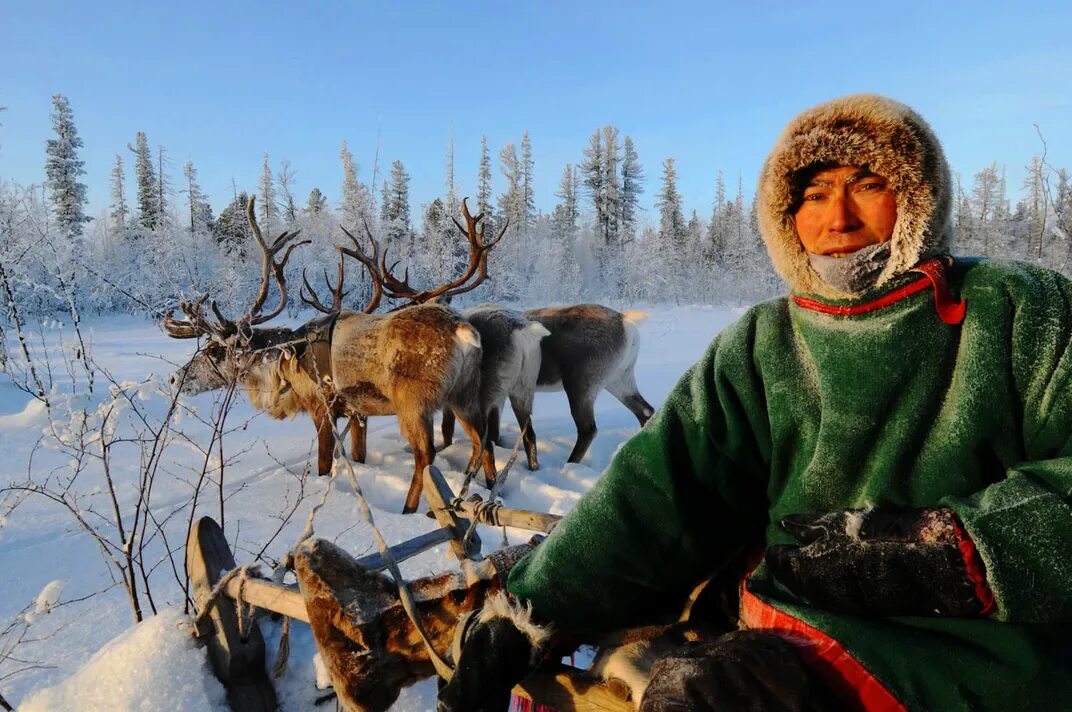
[164,198,506,514]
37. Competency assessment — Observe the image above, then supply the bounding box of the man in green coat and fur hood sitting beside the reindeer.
[441,95,1072,712]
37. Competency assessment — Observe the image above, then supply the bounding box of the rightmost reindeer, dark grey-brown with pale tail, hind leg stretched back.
[524,305,655,462]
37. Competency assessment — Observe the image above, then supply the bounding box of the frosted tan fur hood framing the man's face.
[756,94,952,299]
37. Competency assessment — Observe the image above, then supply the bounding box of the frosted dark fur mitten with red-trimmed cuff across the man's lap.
[766,508,994,615]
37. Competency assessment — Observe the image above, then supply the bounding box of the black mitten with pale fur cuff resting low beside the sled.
[438,594,550,712]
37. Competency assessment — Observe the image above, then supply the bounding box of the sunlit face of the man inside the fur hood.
[793,165,897,257]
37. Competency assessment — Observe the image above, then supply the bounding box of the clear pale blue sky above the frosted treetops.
[0,0,1072,223]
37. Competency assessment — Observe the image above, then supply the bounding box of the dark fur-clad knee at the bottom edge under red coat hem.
[640,631,837,712]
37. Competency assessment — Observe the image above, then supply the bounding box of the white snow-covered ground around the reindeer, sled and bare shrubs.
[0,307,740,711]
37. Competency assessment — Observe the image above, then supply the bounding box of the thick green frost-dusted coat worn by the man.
[508,261,1072,710]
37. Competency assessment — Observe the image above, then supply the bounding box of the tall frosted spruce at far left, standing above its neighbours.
[45,94,90,239]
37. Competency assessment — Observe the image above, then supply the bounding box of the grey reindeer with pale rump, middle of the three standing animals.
[442,305,550,470]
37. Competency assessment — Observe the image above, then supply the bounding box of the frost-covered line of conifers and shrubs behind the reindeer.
[0,94,1072,318]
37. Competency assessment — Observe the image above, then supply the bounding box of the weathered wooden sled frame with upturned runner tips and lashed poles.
[187,465,634,712]
